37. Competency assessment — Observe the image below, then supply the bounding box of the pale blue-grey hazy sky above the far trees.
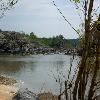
[0,0,100,38]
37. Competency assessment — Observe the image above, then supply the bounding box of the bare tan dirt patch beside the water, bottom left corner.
[0,76,18,100]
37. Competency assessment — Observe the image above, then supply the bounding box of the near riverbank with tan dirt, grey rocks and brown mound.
[0,76,58,100]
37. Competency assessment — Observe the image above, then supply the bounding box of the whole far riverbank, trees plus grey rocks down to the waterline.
[0,30,80,55]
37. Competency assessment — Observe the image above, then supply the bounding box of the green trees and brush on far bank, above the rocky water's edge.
[0,30,79,53]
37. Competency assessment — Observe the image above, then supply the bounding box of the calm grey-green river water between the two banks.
[0,54,79,93]
